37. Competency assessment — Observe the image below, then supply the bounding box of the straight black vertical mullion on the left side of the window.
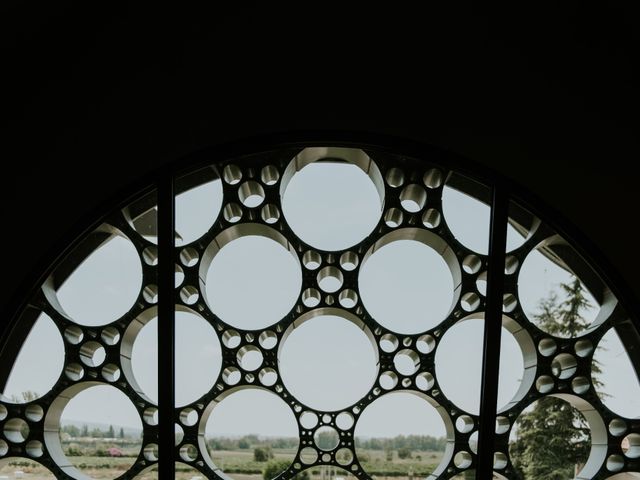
[157,174,175,480]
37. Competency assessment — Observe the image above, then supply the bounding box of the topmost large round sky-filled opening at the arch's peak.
[282,158,382,251]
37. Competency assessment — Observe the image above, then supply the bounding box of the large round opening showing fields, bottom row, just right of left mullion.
[201,388,299,476]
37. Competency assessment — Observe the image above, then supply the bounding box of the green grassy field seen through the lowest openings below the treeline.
[0,449,442,480]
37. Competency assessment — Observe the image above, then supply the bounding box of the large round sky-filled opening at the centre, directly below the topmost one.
[279,312,377,410]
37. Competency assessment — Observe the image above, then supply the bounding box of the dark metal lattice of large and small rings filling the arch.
[0,147,640,479]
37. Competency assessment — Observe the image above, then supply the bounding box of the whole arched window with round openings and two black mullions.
[0,143,640,480]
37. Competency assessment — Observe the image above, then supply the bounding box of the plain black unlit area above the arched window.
[0,1,640,328]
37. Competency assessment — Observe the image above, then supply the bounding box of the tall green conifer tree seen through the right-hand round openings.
[509,278,602,480]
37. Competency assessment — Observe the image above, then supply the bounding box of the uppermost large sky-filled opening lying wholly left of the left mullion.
[56,235,142,326]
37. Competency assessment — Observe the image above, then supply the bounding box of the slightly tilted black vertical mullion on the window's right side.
[476,184,509,479]
